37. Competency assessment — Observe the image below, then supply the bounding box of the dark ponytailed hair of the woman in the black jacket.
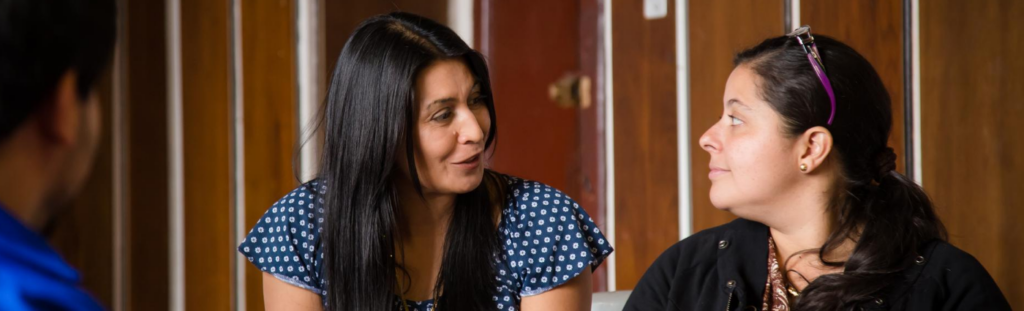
[734,35,946,310]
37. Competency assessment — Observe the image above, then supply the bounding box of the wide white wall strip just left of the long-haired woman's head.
[296,0,322,182]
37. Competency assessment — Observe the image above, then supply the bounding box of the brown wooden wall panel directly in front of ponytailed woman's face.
[689,0,783,232]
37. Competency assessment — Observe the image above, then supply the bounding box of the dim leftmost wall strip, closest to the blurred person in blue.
[110,0,128,311]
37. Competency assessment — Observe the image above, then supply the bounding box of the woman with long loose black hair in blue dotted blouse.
[239,13,612,311]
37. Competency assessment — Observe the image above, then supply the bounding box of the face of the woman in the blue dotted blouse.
[399,59,490,194]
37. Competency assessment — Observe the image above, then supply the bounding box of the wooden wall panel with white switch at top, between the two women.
[610,1,684,291]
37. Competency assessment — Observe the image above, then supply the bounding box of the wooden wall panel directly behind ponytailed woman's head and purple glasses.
[800,0,906,173]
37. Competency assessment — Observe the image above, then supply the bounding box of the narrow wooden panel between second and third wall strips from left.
[180,0,236,310]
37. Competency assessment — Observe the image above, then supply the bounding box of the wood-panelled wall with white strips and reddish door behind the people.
[51,0,1024,310]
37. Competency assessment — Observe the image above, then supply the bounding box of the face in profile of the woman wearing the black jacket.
[699,64,801,220]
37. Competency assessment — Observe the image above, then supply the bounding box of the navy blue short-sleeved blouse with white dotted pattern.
[239,177,612,311]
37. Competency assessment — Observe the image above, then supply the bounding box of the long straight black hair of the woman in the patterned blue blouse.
[317,13,504,310]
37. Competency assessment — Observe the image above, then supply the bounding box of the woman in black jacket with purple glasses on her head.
[626,27,1010,311]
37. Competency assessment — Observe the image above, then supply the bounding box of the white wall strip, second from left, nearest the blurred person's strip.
[166,0,185,311]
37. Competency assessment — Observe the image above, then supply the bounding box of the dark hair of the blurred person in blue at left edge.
[0,0,117,142]
